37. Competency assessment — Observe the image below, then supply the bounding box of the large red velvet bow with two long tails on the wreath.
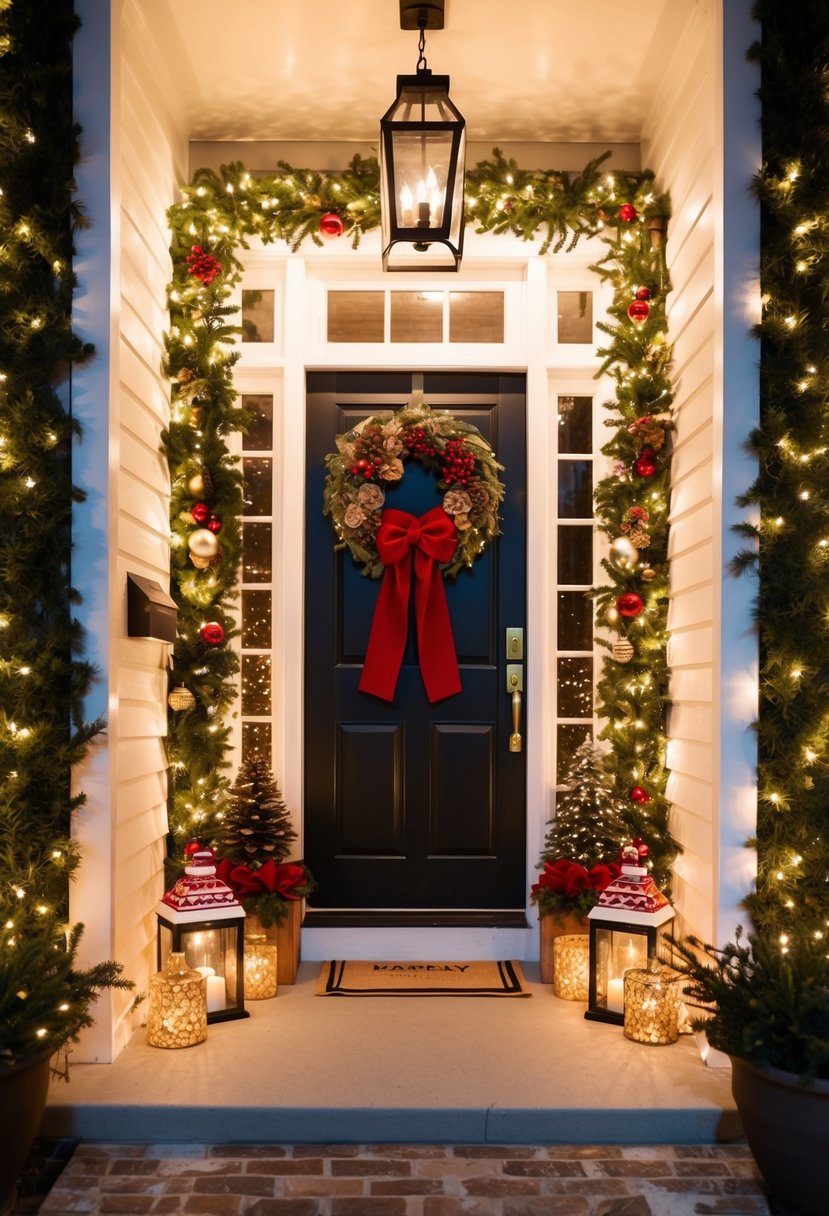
[360,507,461,702]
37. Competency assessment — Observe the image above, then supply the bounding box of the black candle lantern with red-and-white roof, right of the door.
[585,841,673,1026]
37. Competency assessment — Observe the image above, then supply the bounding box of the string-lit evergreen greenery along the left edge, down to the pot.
[0,0,131,1064]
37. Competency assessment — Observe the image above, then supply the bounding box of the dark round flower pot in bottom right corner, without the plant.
[731,1055,829,1216]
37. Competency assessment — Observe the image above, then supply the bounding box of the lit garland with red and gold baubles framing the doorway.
[164,148,677,888]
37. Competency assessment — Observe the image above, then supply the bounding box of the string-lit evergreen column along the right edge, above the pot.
[735,0,829,947]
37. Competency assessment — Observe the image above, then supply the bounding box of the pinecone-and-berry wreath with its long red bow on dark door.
[323,404,504,702]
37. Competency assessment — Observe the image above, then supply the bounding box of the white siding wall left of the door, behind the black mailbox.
[72,0,187,1060]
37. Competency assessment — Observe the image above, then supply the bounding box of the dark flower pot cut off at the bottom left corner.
[0,1052,51,1216]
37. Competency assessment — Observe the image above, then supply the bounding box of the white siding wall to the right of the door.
[643,0,757,940]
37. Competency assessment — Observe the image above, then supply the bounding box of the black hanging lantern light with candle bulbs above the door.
[380,0,467,271]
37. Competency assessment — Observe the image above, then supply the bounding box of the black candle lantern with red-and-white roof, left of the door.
[156,844,249,1023]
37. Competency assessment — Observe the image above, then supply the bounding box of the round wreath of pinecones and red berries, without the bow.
[323,404,504,579]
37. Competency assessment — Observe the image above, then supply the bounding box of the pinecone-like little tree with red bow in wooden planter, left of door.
[215,754,315,984]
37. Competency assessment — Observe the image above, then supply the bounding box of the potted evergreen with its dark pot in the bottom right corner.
[671,929,829,1216]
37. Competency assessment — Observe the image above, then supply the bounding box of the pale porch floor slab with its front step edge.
[40,963,740,1144]
